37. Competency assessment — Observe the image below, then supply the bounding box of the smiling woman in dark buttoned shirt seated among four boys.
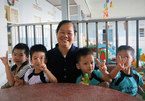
[47,20,81,83]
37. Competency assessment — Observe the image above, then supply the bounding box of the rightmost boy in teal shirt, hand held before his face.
[110,45,144,96]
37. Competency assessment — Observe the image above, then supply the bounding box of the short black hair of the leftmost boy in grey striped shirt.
[12,43,29,56]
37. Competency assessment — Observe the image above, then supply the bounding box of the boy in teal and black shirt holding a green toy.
[76,48,111,85]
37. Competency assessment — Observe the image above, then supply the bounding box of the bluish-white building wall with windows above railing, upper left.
[5,0,61,23]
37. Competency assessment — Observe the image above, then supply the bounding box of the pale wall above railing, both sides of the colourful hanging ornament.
[86,0,145,19]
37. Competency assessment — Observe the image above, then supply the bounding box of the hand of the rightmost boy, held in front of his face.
[117,56,127,70]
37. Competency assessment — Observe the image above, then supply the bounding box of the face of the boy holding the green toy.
[76,55,94,74]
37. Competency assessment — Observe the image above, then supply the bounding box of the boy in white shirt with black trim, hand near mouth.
[24,44,57,85]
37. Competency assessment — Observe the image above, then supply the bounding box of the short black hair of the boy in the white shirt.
[30,44,47,60]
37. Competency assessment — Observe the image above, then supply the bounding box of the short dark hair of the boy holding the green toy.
[76,47,93,63]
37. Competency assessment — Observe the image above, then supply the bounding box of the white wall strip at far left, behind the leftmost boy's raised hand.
[0,0,8,86]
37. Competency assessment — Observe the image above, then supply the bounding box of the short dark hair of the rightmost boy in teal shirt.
[116,45,134,58]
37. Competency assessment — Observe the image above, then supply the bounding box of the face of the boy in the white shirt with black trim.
[31,52,46,70]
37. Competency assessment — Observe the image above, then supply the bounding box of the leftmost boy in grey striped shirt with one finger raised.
[0,43,30,88]
